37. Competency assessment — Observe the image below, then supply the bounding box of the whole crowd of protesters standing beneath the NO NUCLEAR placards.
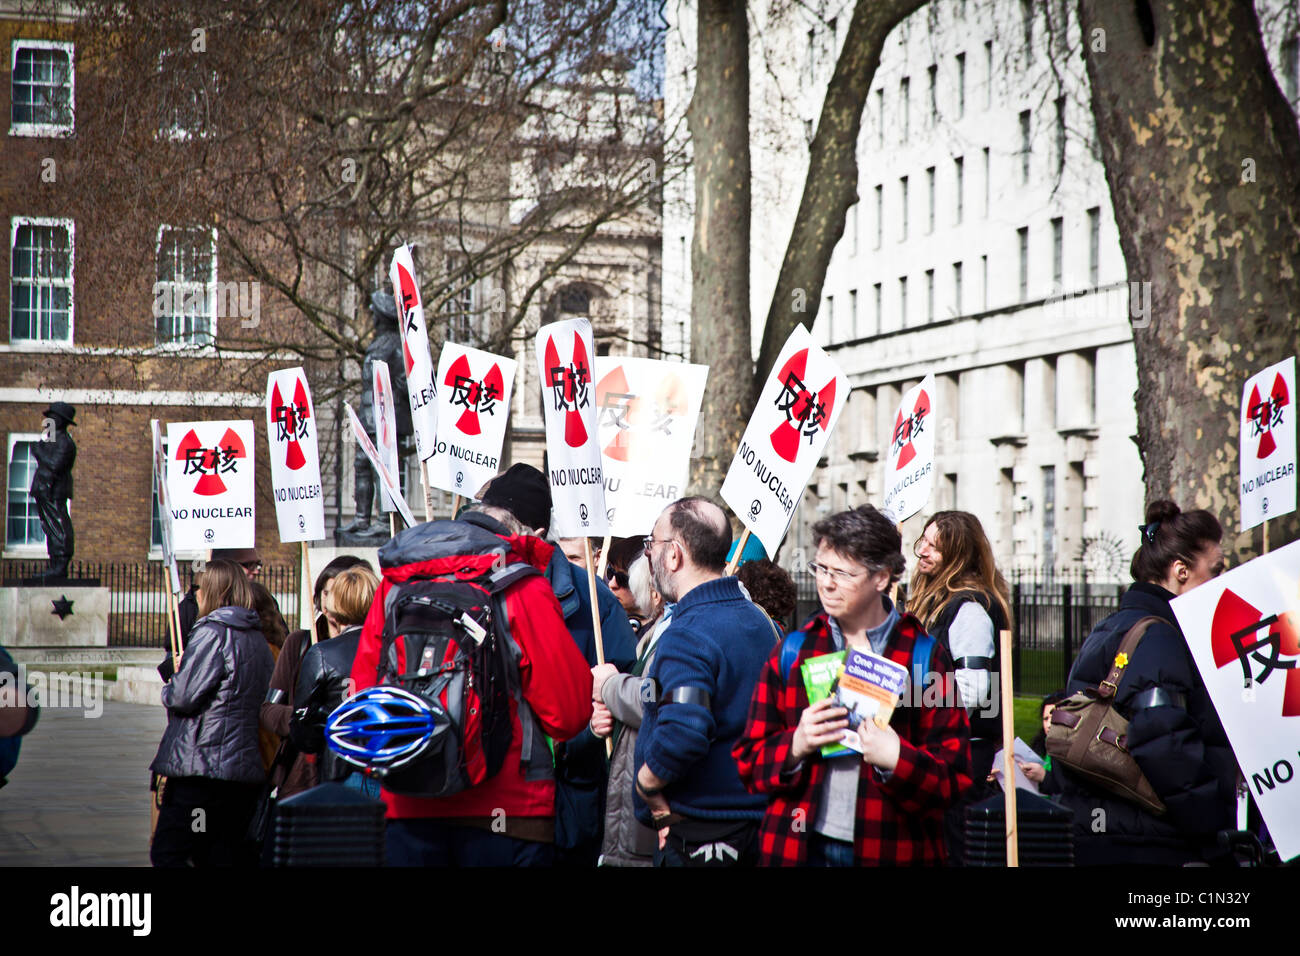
[142,464,1236,866]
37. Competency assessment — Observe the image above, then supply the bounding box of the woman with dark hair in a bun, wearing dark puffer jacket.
[1061,501,1236,866]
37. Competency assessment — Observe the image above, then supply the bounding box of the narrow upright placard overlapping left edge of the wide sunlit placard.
[537,319,608,537]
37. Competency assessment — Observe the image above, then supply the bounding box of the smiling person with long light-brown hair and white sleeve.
[907,511,1011,780]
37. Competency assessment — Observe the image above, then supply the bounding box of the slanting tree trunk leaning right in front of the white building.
[753,0,926,401]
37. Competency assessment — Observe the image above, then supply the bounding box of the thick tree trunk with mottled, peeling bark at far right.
[1079,0,1300,559]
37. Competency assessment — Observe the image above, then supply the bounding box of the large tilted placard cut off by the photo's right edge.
[1170,541,1300,860]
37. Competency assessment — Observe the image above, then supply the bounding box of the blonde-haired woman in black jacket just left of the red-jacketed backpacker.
[289,566,380,797]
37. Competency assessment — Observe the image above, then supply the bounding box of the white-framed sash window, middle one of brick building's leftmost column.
[9,219,73,342]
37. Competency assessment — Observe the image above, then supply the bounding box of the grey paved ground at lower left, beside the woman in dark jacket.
[0,701,166,866]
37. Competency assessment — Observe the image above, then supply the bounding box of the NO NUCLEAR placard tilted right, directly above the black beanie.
[429,342,517,498]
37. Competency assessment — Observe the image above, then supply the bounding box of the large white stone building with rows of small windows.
[663,0,1296,579]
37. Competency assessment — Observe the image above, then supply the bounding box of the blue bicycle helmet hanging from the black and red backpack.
[325,684,450,770]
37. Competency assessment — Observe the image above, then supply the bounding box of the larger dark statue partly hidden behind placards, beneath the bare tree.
[335,291,412,544]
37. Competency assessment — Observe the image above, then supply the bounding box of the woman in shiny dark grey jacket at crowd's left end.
[150,561,273,866]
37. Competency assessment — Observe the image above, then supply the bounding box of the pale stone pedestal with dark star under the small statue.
[0,581,112,648]
